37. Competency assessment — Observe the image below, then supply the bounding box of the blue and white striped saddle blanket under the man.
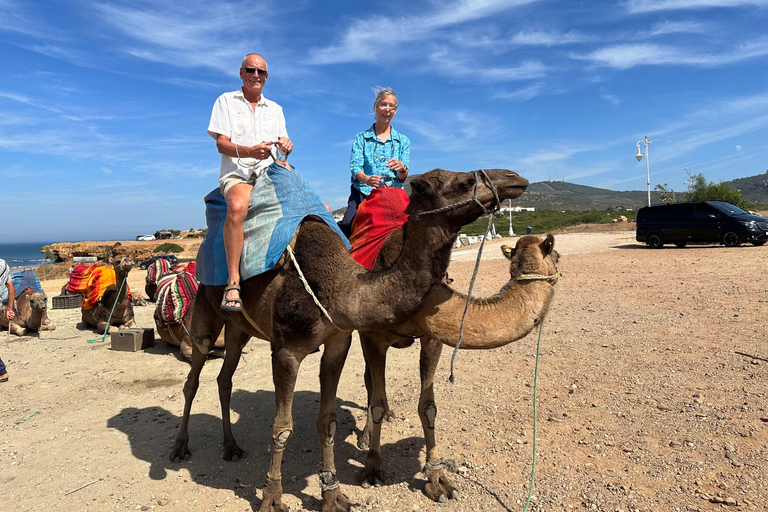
[196,163,350,286]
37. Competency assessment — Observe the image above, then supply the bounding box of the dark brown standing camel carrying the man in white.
[170,169,528,512]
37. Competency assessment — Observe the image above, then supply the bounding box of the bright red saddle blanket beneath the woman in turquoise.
[349,187,408,269]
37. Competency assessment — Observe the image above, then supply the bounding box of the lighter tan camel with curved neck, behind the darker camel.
[358,235,558,501]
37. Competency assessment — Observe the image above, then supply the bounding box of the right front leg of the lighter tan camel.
[419,336,458,502]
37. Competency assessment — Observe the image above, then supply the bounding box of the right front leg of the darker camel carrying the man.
[317,332,352,512]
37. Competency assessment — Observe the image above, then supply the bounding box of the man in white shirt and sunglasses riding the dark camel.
[208,53,293,311]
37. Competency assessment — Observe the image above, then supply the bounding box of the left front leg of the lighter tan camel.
[357,335,389,488]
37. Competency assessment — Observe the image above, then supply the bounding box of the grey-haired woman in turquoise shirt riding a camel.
[339,88,411,238]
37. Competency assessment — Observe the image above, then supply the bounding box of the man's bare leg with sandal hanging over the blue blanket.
[224,183,253,307]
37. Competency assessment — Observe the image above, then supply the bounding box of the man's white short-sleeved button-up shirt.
[208,89,288,183]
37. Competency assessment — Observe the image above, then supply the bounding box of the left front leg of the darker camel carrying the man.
[259,332,305,512]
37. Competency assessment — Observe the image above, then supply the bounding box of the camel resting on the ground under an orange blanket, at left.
[81,254,136,334]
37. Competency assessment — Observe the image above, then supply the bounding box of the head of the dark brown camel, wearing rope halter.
[406,169,528,226]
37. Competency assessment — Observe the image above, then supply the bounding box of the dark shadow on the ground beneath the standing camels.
[107,390,374,510]
